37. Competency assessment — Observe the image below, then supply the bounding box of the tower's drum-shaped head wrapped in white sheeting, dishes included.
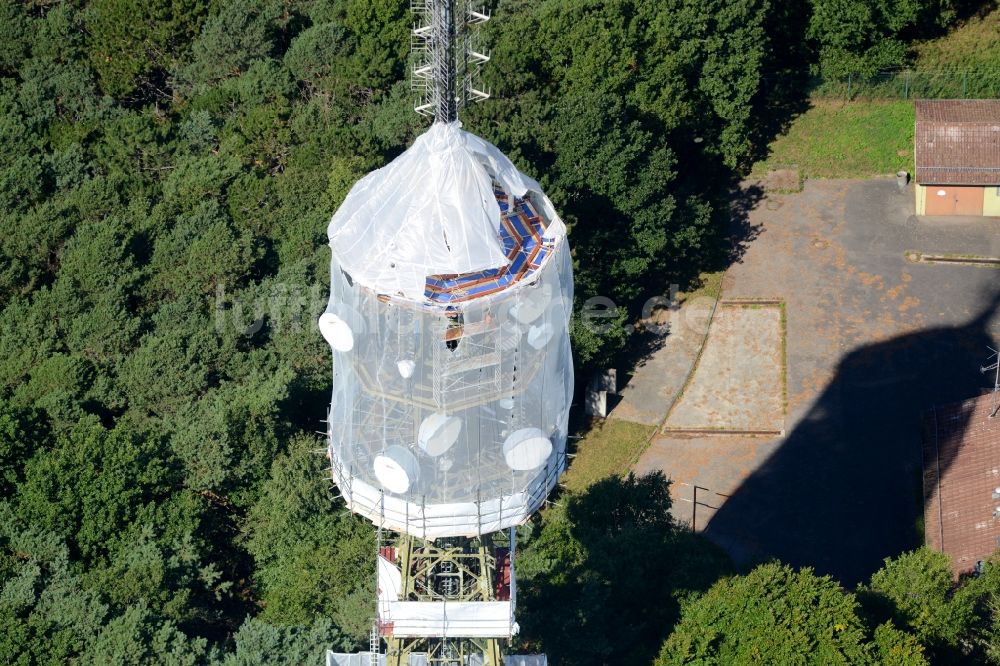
[320,123,573,540]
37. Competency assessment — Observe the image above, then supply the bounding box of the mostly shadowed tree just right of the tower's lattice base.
[517,473,727,664]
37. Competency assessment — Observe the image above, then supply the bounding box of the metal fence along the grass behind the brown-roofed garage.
[808,67,1000,100]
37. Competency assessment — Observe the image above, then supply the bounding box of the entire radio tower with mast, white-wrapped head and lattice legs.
[318,0,574,666]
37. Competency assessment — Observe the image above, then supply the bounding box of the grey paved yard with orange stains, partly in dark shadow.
[640,180,1000,585]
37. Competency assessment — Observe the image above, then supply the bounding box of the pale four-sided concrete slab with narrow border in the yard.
[665,303,785,432]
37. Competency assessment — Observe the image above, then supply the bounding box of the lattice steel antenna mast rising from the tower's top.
[410,0,490,123]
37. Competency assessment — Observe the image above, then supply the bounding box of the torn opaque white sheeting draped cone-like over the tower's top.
[328,123,566,300]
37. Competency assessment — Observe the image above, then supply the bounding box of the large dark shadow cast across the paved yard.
[705,288,1000,586]
